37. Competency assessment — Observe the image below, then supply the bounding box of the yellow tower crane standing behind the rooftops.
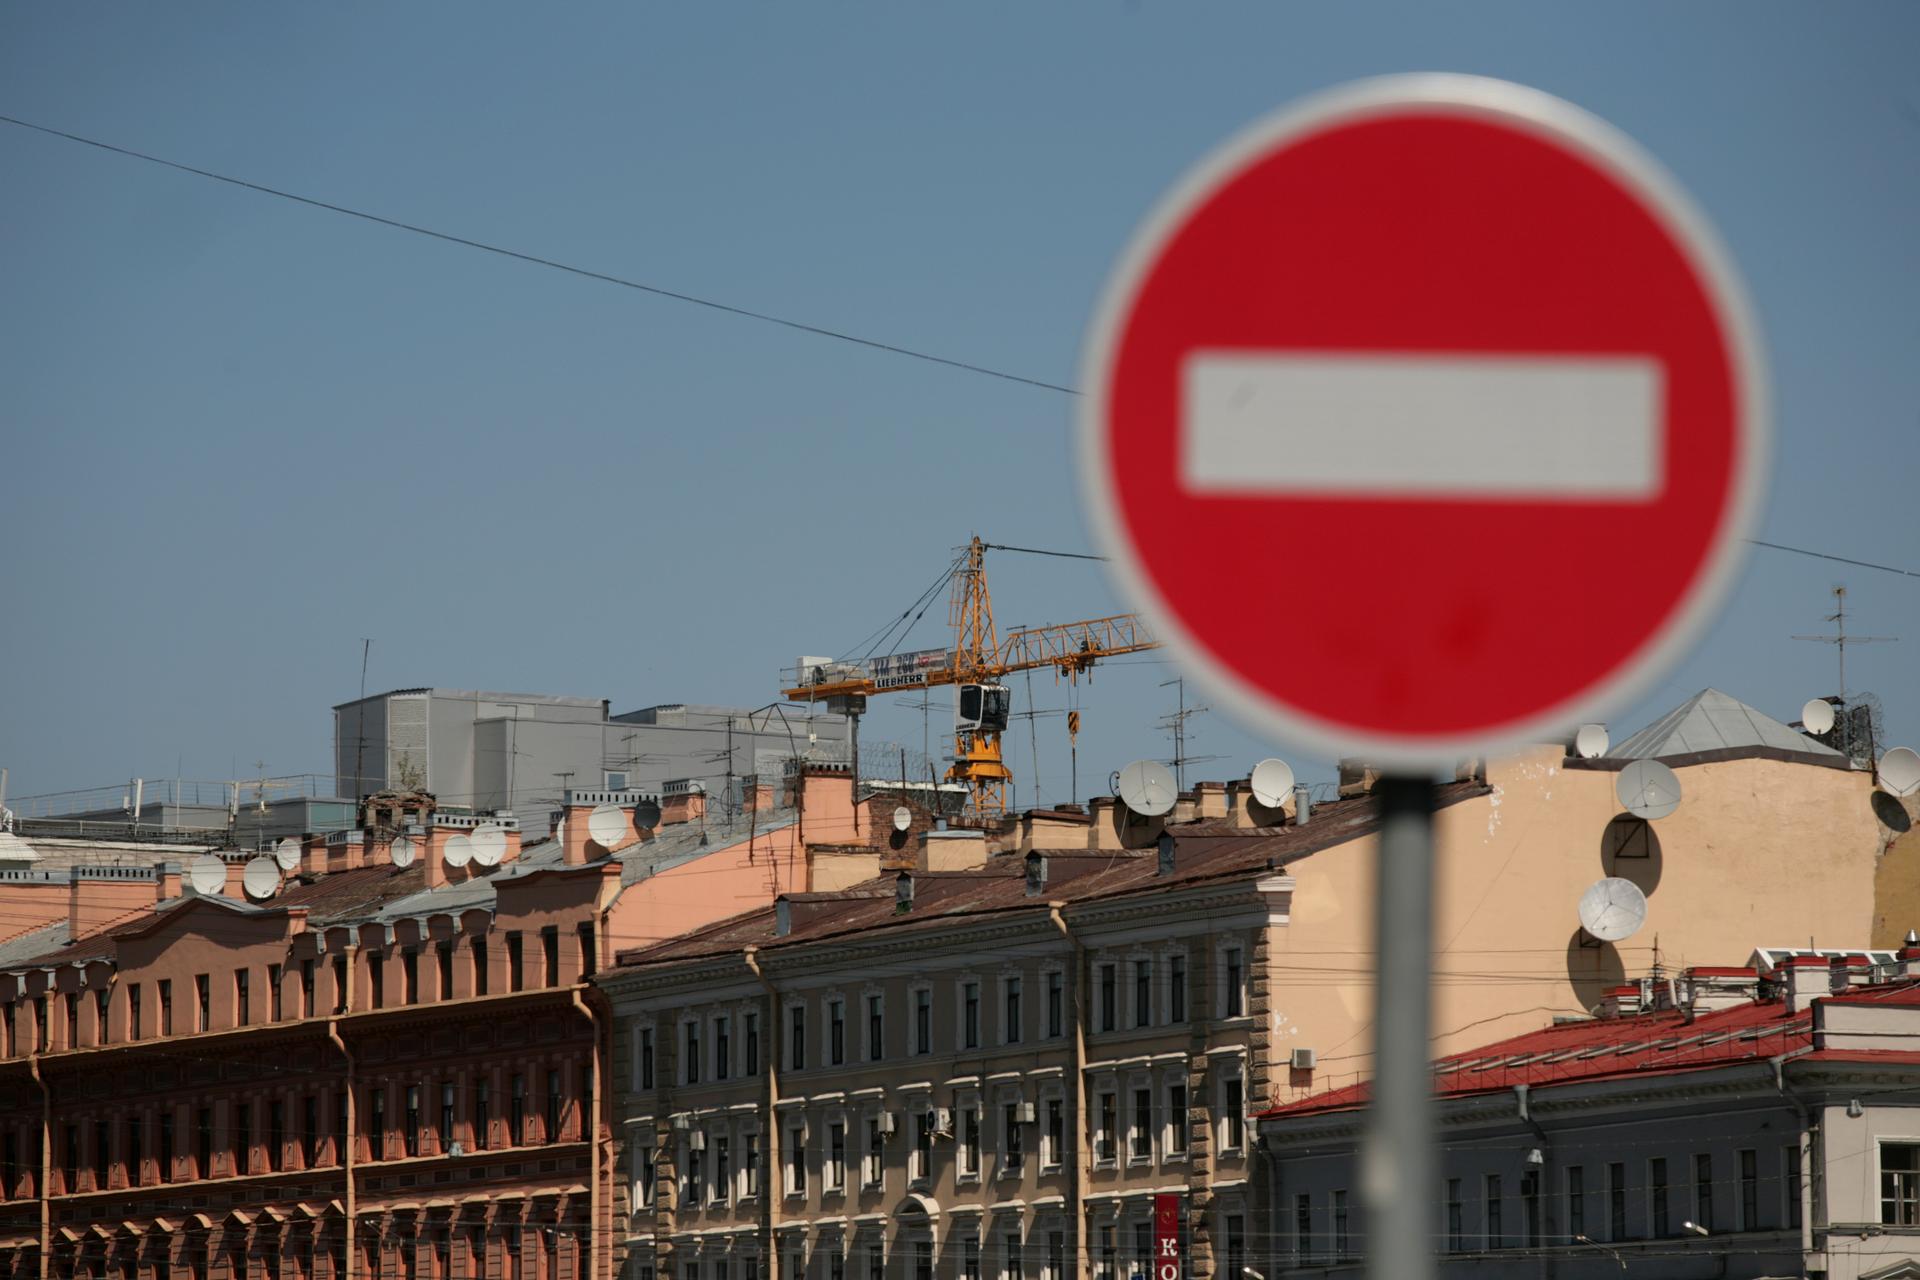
[781,537,1160,818]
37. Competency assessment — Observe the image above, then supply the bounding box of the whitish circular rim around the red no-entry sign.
[1079,73,1772,770]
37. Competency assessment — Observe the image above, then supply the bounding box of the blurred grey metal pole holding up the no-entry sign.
[1361,775,1440,1280]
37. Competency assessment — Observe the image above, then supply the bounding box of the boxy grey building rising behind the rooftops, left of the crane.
[334,689,849,816]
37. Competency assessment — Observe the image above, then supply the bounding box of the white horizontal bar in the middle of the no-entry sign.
[1181,351,1665,499]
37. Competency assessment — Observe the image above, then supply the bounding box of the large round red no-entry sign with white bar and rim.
[1081,75,1766,764]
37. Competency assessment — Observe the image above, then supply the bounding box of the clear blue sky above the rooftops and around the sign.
[0,2,1920,802]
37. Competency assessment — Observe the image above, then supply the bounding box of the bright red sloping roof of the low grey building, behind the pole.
[1263,994,1804,1117]
